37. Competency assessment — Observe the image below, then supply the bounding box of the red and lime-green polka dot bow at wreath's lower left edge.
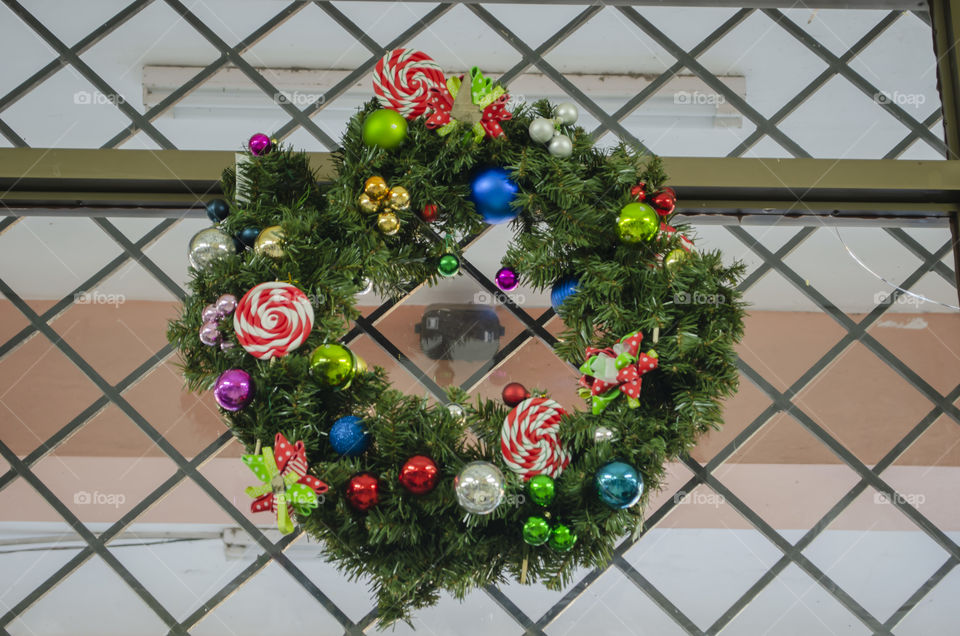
[243,433,328,534]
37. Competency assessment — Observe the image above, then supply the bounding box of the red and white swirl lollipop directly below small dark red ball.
[500,398,570,480]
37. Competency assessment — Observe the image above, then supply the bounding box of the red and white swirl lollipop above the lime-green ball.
[373,49,446,119]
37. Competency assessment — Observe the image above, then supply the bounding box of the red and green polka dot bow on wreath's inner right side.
[580,331,658,415]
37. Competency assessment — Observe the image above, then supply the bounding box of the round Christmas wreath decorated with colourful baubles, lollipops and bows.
[168,50,744,625]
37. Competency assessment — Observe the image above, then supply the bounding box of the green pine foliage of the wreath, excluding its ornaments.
[168,101,744,626]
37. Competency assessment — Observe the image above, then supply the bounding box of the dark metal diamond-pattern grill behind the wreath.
[0,0,960,634]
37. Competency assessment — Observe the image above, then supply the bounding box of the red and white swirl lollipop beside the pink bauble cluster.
[233,281,313,360]
